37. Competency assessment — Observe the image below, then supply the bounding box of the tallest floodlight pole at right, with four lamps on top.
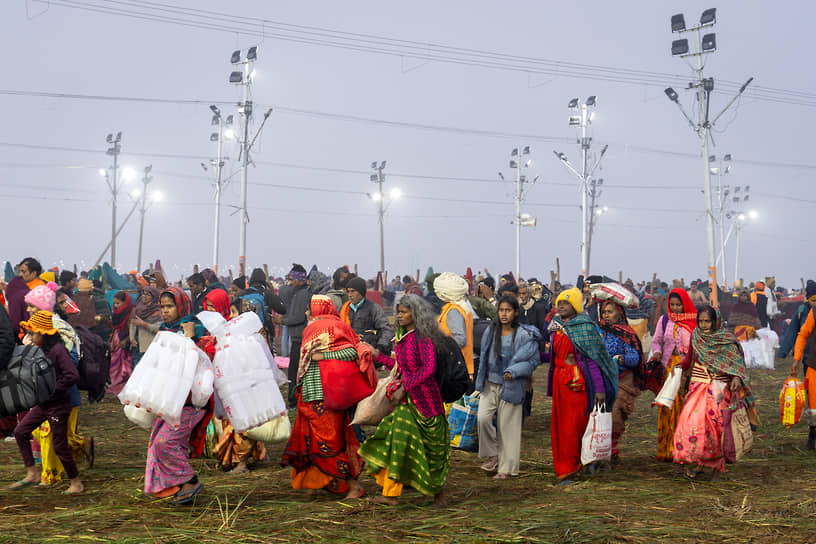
[664,8,753,308]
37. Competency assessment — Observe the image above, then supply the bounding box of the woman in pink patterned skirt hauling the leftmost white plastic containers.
[144,287,212,505]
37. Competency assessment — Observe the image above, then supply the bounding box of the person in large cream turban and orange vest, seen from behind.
[433,272,474,380]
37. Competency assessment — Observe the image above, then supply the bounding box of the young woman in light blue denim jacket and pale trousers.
[474,295,541,480]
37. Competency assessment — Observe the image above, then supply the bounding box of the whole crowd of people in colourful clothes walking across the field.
[0,257,816,505]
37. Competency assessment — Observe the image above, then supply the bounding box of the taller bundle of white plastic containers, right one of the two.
[198,312,286,432]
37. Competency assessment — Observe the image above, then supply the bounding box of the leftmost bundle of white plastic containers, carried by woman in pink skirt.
[119,331,213,426]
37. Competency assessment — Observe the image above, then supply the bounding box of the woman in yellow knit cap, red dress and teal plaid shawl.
[547,288,618,485]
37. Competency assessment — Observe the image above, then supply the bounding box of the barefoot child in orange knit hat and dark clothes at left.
[11,310,85,494]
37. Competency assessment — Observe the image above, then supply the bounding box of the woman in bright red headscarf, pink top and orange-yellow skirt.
[650,288,697,463]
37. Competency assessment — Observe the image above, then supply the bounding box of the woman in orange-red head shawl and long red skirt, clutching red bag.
[281,295,376,498]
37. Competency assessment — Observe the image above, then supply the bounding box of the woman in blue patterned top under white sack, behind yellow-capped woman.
[600,300,643,465]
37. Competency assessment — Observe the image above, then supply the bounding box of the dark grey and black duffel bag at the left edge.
[0,346,57,416]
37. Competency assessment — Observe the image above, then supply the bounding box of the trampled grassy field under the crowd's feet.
[0,361,816,544]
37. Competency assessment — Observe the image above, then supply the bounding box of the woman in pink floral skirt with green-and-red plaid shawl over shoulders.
[673,305,759,479]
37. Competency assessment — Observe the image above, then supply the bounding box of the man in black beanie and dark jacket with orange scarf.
[340,276,394,362]
